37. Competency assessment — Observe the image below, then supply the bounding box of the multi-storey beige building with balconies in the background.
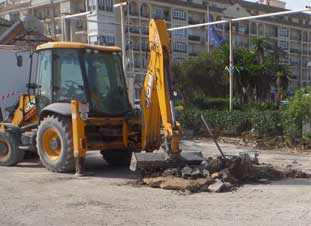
[0,0,311,100]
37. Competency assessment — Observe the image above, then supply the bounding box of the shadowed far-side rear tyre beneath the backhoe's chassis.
[100,149,132,166]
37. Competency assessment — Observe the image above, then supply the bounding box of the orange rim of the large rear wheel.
[42,128,62,160]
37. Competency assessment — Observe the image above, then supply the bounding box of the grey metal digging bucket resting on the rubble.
[130,152,204,171]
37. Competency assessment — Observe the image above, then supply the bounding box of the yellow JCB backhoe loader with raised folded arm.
[0,20,203,174]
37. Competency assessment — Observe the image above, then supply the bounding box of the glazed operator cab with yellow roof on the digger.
[28,42,131,116]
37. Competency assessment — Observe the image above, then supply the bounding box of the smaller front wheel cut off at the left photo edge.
[0,131,25,166]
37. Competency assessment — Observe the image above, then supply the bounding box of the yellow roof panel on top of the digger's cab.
[37,42,121,52]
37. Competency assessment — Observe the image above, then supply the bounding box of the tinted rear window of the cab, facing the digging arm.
[83,49,129,115]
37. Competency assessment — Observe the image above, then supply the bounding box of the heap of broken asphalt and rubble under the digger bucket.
[140,153,311,193]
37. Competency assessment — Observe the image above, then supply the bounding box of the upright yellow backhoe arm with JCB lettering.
[141,20,181,154]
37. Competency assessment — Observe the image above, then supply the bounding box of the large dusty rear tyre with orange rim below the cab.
[37,115,75,173]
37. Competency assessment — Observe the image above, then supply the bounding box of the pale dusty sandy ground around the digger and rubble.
[0,141,311,226]
